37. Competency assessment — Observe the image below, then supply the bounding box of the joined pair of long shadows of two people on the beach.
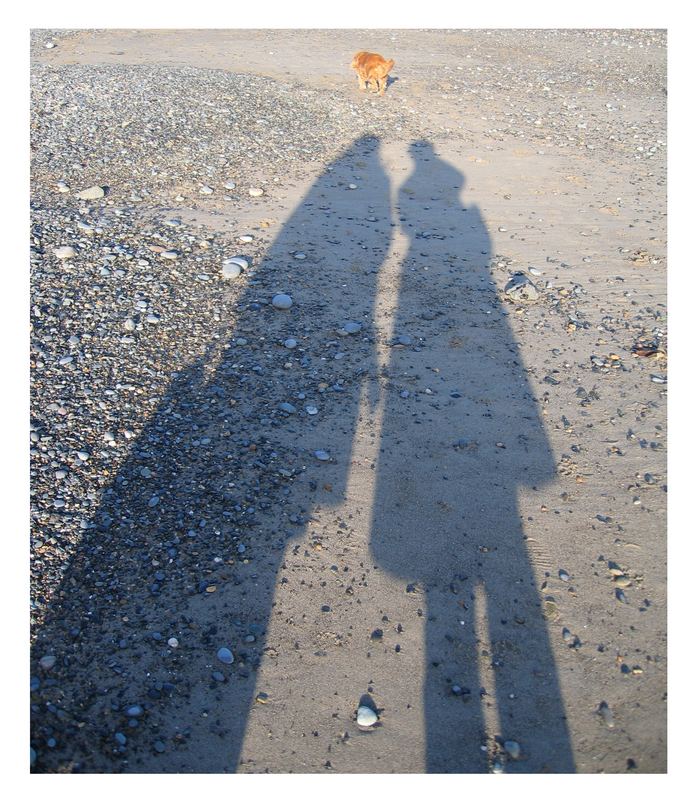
[32,137,573,772]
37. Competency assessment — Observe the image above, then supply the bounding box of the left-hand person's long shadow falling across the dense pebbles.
[31,137,391,772]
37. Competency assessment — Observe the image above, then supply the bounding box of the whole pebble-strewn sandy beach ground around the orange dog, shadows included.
[30,30,667,772]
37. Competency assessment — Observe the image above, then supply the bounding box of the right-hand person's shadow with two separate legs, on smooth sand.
[371,141,574,772]
